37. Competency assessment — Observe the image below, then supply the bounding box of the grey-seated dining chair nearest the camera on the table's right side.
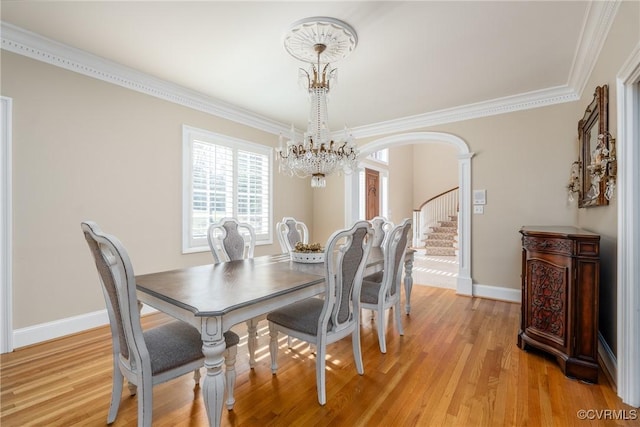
[267,221,373,405]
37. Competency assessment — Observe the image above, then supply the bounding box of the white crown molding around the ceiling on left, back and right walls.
[0,0,621,138]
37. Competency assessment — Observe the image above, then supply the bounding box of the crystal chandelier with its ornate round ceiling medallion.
[276,17,358,188]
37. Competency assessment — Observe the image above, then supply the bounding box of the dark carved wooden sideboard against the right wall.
[518,226,600,383]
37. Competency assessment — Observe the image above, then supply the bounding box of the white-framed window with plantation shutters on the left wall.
[182,126,272,253]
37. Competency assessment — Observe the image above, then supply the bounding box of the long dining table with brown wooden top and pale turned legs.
[135,248,415,427]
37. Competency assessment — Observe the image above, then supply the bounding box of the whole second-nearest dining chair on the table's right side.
[360,218,411,353]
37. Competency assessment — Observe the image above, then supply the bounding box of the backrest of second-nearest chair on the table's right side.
[382,218,411,299]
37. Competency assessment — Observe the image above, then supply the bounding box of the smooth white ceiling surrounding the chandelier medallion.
[1,0,591,135]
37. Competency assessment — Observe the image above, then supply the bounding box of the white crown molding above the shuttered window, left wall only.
[1,22,288,134]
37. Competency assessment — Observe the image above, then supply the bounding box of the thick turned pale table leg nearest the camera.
[202,332,226,427]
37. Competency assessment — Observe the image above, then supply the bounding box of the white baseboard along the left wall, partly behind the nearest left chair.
[13,305,156,349]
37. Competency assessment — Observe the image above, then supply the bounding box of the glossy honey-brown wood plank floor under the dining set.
[0,286,640,427]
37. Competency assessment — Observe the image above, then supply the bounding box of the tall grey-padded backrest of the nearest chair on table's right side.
[318,221,373,333]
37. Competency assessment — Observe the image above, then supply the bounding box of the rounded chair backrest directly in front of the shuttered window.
[207,217,256,263]
